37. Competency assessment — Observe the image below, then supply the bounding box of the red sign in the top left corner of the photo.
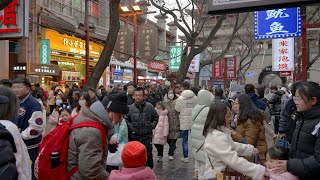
[0,0,20,33]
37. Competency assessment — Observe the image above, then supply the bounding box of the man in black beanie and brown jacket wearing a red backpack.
[67,94,129,180]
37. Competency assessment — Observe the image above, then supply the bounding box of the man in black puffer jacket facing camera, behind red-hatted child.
[127,87,159,168]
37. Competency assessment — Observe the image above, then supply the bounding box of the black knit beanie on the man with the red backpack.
[102,92,129,114]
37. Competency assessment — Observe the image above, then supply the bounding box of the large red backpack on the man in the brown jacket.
[34,117,107,180]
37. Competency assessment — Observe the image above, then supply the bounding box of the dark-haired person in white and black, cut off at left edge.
[0,87,32,180]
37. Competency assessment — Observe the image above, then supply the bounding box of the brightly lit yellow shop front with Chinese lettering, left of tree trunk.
[42,28,103,84]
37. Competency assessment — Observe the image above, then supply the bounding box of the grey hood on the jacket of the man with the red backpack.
[90,101,114,140]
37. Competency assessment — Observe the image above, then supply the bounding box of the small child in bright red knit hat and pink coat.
[109,141,156,180]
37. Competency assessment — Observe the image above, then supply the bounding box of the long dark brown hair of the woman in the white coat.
[202,102,229,137]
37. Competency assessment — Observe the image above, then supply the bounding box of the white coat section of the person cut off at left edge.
[0,120,32,180]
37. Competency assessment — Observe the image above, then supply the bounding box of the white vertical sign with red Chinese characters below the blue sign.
[272,38,294,71]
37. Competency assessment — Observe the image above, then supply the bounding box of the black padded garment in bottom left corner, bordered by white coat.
[0,124,18,180]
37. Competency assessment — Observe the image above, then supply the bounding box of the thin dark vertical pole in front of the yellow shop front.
[84,0,90,81]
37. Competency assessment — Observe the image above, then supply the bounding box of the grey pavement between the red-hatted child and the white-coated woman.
[153,139,194,180]
